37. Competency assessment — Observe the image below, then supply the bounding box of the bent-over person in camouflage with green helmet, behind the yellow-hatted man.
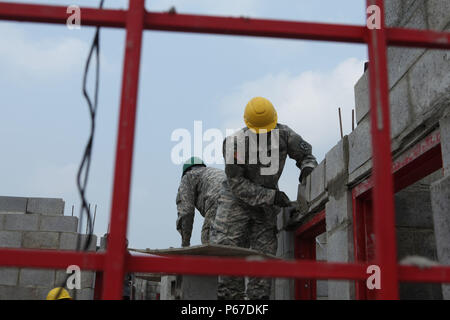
[176,157,226,247]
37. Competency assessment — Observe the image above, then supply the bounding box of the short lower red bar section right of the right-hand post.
[398,266,450,283]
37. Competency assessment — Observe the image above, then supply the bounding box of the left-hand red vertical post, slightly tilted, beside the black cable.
[102,0,145,300]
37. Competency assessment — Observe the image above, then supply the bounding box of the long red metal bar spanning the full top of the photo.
[0,2,450,49]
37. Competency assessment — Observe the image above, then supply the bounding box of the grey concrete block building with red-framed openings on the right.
[274,0,450,299]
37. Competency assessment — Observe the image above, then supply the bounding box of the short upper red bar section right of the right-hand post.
[386,28,450,49]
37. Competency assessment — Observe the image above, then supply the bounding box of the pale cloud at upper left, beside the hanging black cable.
[0,23,88,79]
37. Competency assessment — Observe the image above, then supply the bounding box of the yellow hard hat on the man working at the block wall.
[244,97,278,133]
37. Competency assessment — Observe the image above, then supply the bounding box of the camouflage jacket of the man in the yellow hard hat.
[223,124,317,207]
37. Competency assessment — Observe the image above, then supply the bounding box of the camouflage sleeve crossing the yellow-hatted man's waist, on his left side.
[223,138,276,207]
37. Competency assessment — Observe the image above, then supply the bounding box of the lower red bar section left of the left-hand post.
[0,248,105,270]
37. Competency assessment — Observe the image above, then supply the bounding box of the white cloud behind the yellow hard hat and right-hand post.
[221,58,363,159]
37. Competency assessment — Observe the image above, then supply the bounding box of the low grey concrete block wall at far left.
[0,197,97,300]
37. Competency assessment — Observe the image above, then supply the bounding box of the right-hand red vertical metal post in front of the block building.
[367,0,398,299]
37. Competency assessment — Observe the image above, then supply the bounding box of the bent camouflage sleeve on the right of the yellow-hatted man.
[288,128,317,169]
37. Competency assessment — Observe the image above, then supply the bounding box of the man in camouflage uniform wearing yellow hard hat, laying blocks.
[212,98,317,300]
